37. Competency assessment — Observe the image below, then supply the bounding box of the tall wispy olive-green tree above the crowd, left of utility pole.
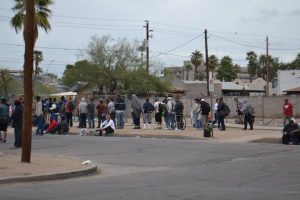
[87,35,141,93]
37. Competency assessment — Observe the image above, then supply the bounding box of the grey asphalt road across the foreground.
[0,135,300,200]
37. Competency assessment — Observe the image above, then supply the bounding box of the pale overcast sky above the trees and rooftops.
[0,0,300,76]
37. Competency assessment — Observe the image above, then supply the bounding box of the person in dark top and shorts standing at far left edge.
[0,97,9,142]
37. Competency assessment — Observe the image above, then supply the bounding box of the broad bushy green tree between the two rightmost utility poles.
[216,56,239,81]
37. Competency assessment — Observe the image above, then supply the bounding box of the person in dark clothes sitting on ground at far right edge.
[282,118,300,144]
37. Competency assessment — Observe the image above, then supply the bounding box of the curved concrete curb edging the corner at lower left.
[0,165,98,184]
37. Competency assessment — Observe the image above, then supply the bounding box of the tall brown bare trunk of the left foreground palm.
[21,0,35,163]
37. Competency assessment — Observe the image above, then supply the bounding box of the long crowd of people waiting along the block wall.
[0,94,300,147]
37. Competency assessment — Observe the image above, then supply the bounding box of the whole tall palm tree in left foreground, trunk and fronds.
[10,0,53,162]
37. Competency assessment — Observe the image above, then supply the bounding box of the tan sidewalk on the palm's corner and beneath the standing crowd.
[0,120,282,184]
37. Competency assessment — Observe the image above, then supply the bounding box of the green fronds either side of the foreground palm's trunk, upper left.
[10,0,53,41]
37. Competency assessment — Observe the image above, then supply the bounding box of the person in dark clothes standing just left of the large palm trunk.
[12,100,23,148]
